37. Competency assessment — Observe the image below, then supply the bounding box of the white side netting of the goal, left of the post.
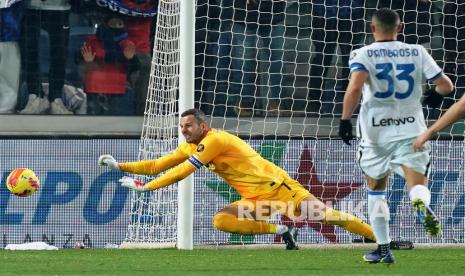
[121,0,180,247]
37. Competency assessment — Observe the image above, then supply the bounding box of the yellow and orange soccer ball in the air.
[6,168,40,197]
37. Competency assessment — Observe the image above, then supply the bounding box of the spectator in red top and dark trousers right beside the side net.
[122,0,158,115]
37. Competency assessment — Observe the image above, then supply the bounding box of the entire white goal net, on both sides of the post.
[126,0,465,246]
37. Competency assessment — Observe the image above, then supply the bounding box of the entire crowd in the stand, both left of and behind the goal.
[0,0,465,116]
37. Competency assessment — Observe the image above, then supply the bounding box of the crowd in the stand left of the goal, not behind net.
[0,0,158,115]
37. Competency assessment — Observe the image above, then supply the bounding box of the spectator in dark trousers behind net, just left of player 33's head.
[307,0,365,116]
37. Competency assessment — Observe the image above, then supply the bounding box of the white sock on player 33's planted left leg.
[368,190,391,244]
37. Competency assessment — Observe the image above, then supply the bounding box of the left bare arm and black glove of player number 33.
[339,67,368,145]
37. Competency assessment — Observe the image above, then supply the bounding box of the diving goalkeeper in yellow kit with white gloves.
[98,109,374,250]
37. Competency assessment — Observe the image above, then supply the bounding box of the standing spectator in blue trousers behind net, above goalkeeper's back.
[217,0,287,117]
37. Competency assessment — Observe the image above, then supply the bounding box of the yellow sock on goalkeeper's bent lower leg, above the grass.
[213,213,276,235]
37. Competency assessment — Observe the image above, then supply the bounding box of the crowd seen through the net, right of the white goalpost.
[196,0,465,118]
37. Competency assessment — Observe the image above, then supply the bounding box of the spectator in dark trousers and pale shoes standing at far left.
[19,0,73,115]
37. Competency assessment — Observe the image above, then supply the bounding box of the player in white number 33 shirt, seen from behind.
[339,9,453,264]
